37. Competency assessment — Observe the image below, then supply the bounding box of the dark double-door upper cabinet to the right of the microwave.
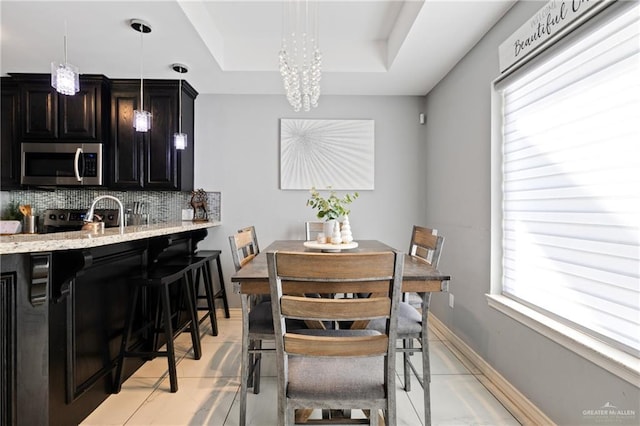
[109,80,198,191]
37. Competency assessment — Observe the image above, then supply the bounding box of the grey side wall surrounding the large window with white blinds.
[420,2,640,425]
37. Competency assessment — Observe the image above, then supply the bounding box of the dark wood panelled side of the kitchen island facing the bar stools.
[49,240,147,425]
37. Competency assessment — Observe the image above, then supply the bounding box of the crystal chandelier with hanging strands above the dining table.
[278,0,322,112]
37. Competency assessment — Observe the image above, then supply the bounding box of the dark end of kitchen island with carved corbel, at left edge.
[0,253,51,425]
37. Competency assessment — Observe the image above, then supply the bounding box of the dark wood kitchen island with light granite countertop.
[0,222,220,425]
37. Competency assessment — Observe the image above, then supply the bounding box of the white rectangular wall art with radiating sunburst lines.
[280,119,374,190]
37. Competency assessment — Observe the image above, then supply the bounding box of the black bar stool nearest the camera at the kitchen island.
[114,265,202,393]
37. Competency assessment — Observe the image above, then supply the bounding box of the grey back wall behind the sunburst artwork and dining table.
[195,95,426,306]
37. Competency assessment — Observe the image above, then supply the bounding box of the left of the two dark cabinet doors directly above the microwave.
[22,82,58,138]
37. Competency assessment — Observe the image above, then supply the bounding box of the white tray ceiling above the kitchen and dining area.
[0,0,515,95]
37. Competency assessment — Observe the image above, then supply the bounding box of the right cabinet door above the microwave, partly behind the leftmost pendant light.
[59,81,102,142]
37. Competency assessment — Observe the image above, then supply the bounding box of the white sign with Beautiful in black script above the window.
[498,0,612,72]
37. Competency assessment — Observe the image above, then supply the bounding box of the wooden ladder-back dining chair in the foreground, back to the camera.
[267,251,403,425]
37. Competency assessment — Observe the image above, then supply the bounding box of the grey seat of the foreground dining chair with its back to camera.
[287,356,386,400]
